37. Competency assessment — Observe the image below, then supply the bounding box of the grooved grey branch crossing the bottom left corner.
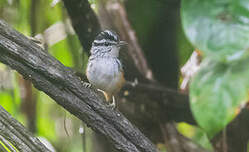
[0,106,50,152]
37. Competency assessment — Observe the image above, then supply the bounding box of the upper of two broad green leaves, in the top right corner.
[181,0,249,60]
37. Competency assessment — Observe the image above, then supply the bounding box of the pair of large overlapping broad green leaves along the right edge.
[182,0,249,138]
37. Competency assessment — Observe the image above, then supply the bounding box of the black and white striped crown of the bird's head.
[93,30,120,46]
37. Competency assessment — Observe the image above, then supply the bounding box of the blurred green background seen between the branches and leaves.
[0,0,247,152]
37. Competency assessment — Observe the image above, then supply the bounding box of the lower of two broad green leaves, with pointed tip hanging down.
[190,58,249,138]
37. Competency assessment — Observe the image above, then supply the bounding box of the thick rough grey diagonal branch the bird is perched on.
[0,20,157,152]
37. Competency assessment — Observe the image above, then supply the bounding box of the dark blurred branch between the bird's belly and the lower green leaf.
[120,82,196,125]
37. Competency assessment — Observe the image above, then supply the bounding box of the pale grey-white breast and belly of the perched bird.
[87,58,122,92]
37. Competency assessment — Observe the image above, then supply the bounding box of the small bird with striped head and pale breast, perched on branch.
[86,30,127,108]
